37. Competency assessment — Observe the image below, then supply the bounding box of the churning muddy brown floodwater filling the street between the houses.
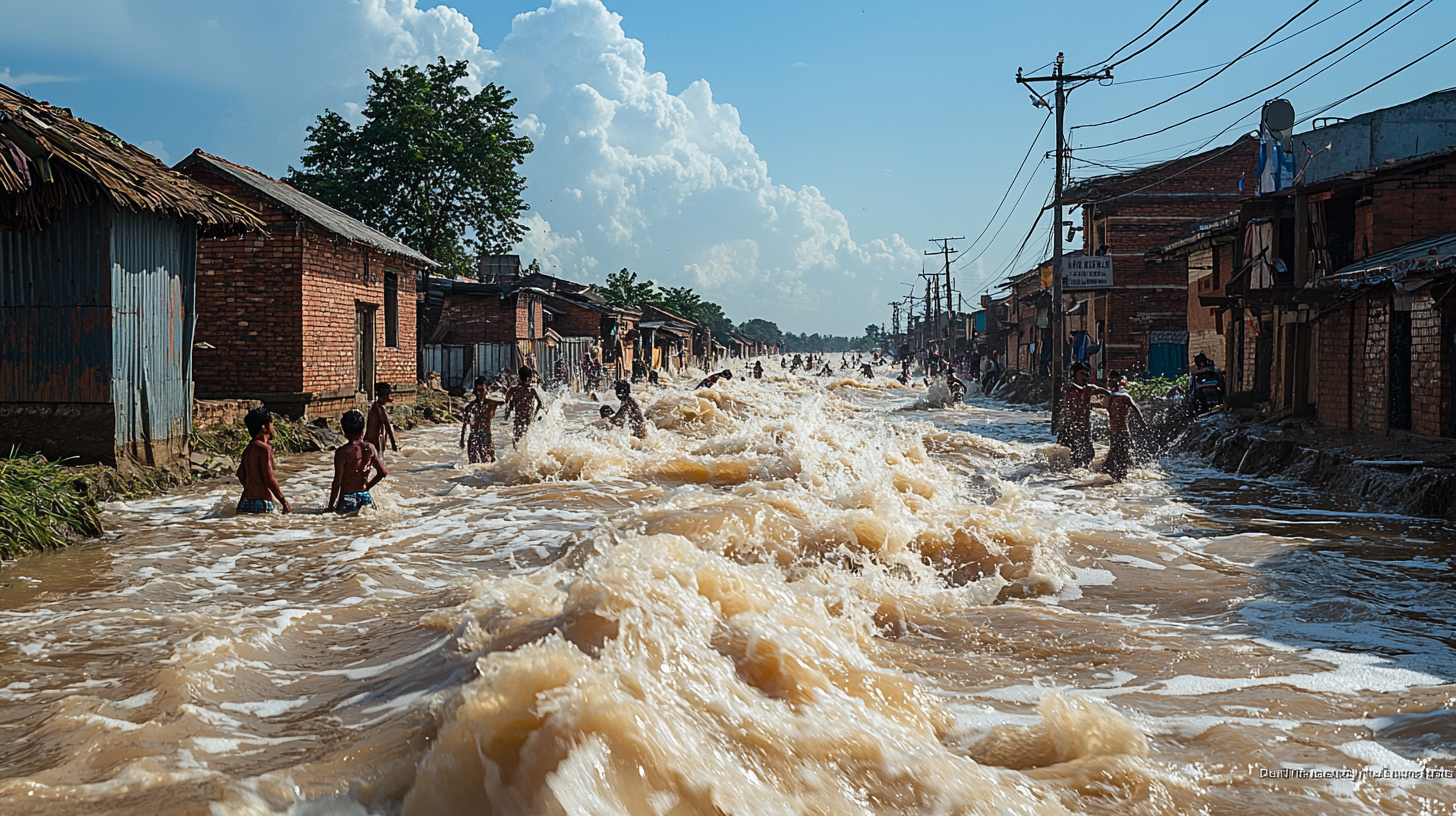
[0,364,1456,816]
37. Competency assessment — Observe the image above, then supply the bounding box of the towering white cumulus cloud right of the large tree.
[363,0,919,334]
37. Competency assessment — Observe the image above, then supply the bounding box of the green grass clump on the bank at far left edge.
[0,450,102,558]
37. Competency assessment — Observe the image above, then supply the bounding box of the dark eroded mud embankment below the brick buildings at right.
[1172,412,1456,517]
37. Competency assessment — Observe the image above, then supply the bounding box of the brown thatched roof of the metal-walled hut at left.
[0,85,264,232]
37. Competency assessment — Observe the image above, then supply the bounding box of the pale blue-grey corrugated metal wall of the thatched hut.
[111,211,197,454]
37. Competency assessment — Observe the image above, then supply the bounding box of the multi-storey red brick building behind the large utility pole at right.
[1063,136,1259,376]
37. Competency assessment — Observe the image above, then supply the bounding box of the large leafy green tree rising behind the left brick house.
[284,57,534,275]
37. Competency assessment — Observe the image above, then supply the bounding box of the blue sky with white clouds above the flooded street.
[0,0,1456,334]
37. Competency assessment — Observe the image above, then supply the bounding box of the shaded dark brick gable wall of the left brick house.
[191,178,303,398]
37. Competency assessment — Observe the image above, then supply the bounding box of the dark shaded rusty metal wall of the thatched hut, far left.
[0,204,111,404]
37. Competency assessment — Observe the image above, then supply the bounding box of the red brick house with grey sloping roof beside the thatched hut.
[175,150,438,417]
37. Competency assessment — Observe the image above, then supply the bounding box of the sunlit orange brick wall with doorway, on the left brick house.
[300,226,418,393]
